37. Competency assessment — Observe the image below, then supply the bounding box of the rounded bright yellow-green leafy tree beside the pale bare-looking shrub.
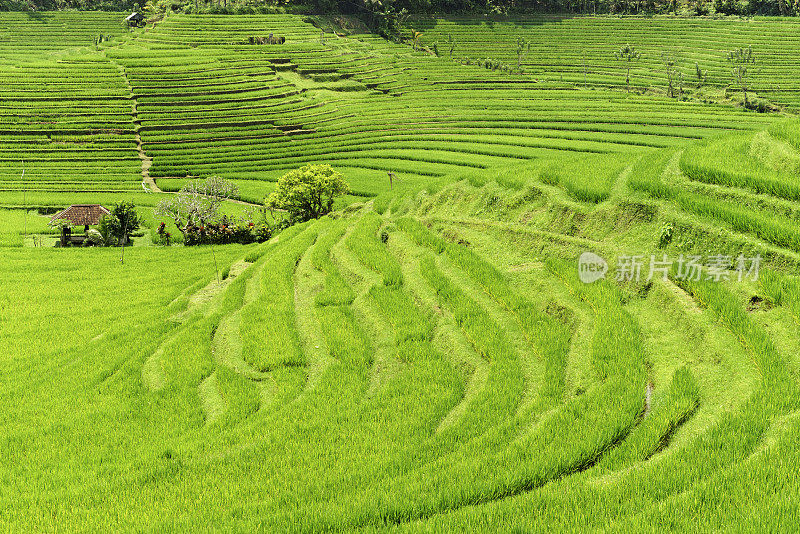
[266,165,350,222]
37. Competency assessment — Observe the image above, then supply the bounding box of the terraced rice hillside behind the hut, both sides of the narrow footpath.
[0,14,780,206]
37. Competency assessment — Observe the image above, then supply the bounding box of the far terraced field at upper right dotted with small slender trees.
[408,16,800,109]
